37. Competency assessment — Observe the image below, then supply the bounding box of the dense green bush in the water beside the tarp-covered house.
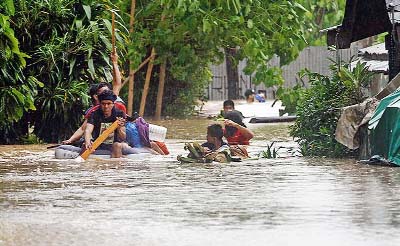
[290,63,373,157]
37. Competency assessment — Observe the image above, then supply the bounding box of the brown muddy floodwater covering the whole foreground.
[0,120,400,246]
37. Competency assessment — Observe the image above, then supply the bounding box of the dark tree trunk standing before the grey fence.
[225,48,239,99]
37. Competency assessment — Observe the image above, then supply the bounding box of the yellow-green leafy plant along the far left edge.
[0,0,43,144]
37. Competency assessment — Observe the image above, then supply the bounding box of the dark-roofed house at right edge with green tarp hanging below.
[327,0,400,166]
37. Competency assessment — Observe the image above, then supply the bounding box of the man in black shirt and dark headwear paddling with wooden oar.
[84,90,126,158]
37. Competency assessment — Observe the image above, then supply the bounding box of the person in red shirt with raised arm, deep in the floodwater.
[224,111,254,145]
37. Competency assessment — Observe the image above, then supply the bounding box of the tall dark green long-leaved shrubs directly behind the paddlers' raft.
[6,0,126,142]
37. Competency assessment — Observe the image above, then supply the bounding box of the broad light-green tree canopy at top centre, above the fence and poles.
[117,0,306,115]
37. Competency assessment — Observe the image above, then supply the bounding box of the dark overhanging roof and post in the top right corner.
[327,0,400,81]
